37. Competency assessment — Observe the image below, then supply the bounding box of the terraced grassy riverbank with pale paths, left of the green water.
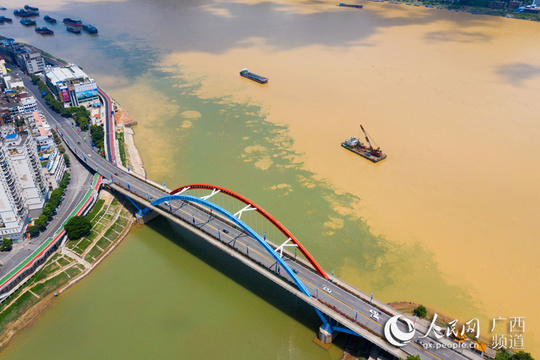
[0,190,134,351]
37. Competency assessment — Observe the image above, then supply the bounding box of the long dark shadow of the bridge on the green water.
[145,217,348,349]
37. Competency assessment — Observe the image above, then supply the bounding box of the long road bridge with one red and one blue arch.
[17,73,481,360]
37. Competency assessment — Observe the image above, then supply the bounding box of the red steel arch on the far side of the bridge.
[170,184,329,279]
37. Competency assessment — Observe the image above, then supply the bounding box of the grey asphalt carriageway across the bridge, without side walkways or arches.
[22,71,482,360]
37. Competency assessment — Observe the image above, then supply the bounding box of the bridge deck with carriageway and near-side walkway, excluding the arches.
[23,73,482,360]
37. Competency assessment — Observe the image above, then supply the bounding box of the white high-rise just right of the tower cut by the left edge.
[4,133,49,217]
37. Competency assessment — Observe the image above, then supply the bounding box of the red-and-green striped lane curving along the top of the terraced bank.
[0,174,102,302]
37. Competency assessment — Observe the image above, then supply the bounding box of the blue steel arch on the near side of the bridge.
[139,195,311,297]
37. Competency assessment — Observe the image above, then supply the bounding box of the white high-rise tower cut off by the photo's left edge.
[0,143,28,241]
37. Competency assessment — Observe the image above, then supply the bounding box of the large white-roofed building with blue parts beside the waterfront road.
[45,64,99,108]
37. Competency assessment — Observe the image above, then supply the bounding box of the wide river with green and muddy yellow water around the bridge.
[0,0,540,359]
